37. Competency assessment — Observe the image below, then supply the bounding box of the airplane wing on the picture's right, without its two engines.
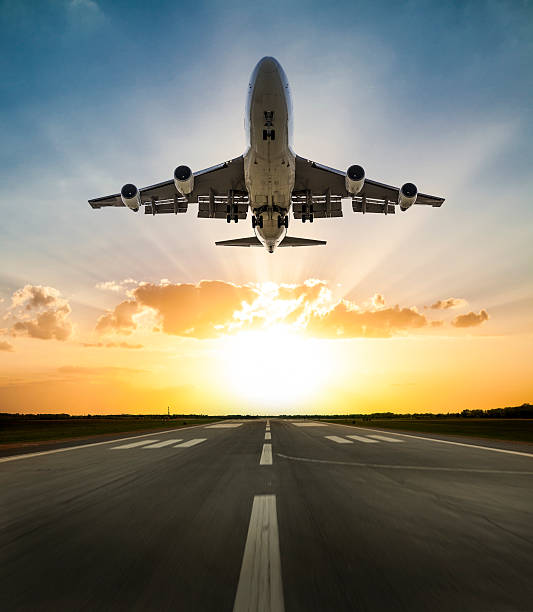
[292,155,444,219]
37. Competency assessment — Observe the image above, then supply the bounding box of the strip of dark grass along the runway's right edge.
[321,418,533,442]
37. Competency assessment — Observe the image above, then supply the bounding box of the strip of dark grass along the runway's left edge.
[0,415,220,448]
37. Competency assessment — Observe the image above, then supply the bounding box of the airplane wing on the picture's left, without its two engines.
[89,155,248,219]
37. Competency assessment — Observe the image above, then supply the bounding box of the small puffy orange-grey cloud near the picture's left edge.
[7,285,72,340]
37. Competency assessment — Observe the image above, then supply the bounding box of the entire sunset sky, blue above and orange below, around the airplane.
[0,0,533,414]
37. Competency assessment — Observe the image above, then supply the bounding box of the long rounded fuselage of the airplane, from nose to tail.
[244,57,295,251]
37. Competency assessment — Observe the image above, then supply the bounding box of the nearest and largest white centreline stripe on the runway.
[233,495,285,612]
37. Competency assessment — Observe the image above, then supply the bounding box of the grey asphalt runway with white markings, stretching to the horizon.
[0,420,533,612]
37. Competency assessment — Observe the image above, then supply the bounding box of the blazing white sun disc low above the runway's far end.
[220,325,332,411]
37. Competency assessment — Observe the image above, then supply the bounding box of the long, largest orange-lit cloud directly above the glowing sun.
[97,279,436,339]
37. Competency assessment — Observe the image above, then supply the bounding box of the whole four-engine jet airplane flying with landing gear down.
[89,57,444,253]
